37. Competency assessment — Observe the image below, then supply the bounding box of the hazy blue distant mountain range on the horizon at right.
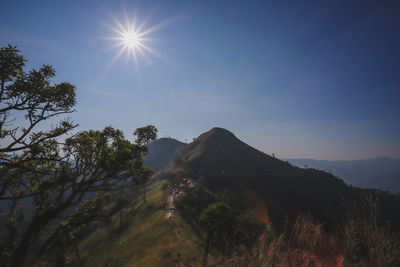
[284,158,400,193]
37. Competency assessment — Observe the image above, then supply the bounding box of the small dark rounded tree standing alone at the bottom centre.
[200,202,237,266]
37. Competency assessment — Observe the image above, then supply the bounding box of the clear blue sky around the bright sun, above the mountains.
[0,0,400,159]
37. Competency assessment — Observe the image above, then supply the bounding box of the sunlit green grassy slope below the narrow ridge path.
[74,181,202,266]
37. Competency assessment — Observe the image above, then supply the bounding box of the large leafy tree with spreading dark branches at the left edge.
[0,45,157,266]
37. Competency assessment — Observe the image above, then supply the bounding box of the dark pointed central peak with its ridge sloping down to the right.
[157,127,350,232]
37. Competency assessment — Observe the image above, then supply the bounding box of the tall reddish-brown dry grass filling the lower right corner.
[220,195,400,267]
